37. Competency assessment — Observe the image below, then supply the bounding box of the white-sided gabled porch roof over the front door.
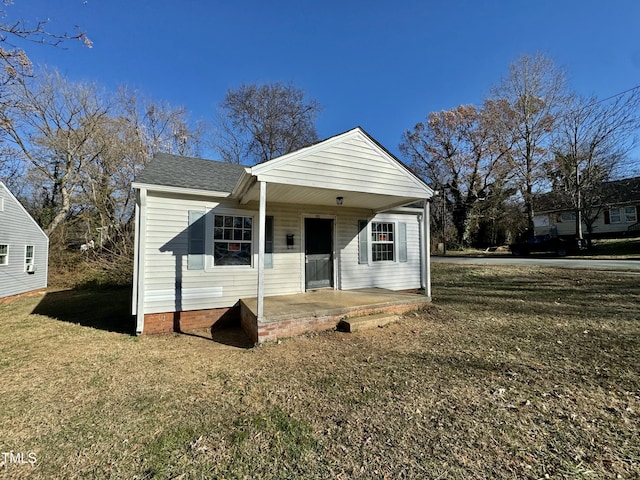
[233,127,433,211]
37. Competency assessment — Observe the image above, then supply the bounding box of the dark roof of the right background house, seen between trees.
[534,177,640,213]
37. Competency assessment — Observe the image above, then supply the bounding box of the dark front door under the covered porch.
[304,218,333,290]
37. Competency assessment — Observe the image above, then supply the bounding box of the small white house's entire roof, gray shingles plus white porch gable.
[133,127,433,208]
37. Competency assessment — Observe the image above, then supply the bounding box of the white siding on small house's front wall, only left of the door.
[144,192,308,313]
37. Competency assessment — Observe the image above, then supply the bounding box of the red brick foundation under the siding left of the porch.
[142,305,240,335]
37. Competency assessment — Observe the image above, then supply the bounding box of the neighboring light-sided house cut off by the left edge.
[0,182,49,298]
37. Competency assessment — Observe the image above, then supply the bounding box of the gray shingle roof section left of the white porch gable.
[136,153,245,192]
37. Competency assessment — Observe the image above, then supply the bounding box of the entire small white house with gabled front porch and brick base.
[132,128,433,343]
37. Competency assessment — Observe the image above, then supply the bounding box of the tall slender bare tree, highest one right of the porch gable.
[491,54,566,233]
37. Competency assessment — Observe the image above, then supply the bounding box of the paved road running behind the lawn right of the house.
[431,255,640,271]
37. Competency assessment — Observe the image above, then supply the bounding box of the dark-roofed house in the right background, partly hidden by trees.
[534,177,640,237]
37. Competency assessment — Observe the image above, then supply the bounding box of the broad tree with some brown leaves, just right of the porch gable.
[400,102,510,244]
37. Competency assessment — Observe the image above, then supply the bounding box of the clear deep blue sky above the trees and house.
[6,0,640,159]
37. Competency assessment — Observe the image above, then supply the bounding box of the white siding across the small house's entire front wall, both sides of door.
[142,192,420,313]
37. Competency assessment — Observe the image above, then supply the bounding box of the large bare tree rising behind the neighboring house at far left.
[0,73,109,234]
